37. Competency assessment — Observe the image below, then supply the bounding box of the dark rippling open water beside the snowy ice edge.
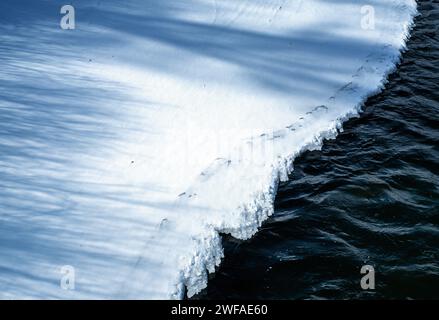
[196,1,439,299]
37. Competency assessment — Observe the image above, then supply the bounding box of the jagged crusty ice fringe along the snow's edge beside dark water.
[170,2,418,299]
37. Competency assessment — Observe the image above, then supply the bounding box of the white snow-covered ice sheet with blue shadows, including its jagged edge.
[0,0,416,299]
